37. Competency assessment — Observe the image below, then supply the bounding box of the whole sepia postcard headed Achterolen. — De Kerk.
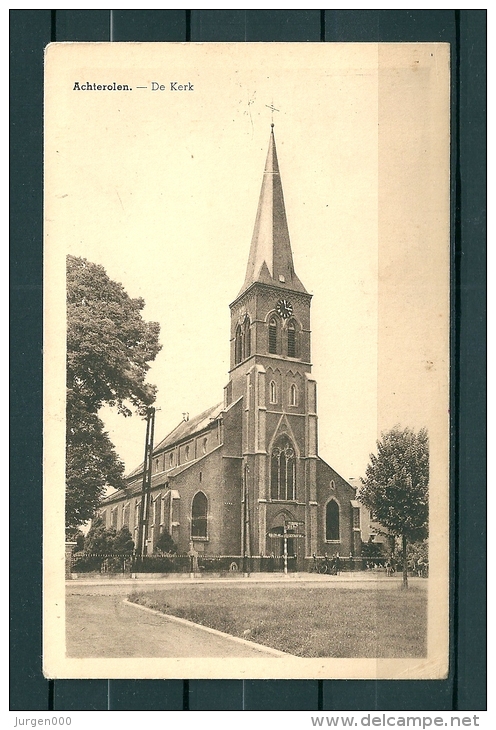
[43,43,450,679]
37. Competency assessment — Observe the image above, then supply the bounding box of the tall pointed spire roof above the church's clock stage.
[240,124,306,294]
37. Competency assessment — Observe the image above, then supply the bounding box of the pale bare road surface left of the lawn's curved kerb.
[66,583,286,659]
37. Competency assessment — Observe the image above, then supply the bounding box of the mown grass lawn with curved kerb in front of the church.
[129,581,427,657]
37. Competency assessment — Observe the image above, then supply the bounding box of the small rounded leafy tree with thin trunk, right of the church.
[358,427,429,588]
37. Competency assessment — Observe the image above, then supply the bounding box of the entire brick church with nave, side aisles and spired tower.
[101,125,361,569]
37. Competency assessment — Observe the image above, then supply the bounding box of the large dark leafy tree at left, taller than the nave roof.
[66,256,161,528]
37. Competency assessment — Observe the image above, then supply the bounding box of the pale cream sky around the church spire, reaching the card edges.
[45,39,449,478]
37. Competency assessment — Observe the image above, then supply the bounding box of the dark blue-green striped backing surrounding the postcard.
[10,10,486,712]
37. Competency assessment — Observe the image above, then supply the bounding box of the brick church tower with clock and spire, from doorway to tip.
[225,125,318,558]
